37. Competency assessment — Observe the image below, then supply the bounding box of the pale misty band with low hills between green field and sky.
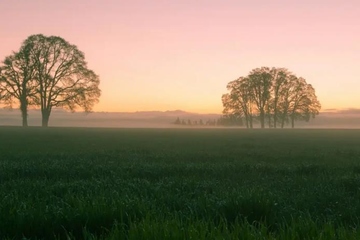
[0,109,360,129]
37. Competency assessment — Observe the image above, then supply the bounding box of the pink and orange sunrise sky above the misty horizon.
[0,0,360,113]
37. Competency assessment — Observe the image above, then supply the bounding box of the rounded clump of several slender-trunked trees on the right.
[222,67,321,128]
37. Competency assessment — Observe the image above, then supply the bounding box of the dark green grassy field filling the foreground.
[0,127,360,239]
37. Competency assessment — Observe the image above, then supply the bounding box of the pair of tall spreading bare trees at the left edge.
[0,34,101,127]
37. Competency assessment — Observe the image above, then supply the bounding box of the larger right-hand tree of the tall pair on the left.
[24,34,101,127]
